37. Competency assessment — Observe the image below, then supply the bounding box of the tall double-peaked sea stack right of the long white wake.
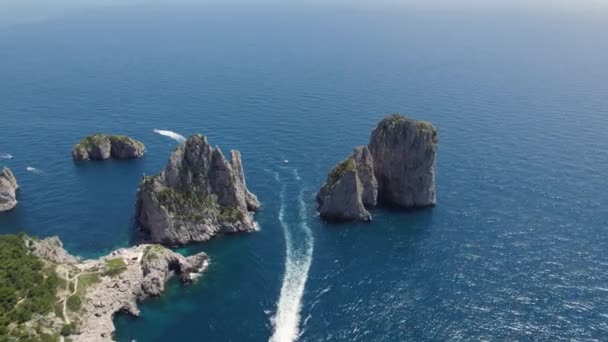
[317,115,438,221]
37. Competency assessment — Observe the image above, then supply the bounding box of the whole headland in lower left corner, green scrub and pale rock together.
[0,234,209,342]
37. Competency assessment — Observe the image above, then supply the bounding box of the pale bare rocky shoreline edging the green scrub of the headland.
[25,237,210,342]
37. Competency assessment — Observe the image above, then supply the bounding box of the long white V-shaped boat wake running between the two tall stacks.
[269,170,314,342]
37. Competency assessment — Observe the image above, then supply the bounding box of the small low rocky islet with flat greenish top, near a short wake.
[72,134,146,161]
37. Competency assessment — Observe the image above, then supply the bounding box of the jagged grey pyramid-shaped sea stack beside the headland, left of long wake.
[136,135,260,245]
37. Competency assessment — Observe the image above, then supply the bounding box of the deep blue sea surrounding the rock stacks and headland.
[0,5,608,342]
